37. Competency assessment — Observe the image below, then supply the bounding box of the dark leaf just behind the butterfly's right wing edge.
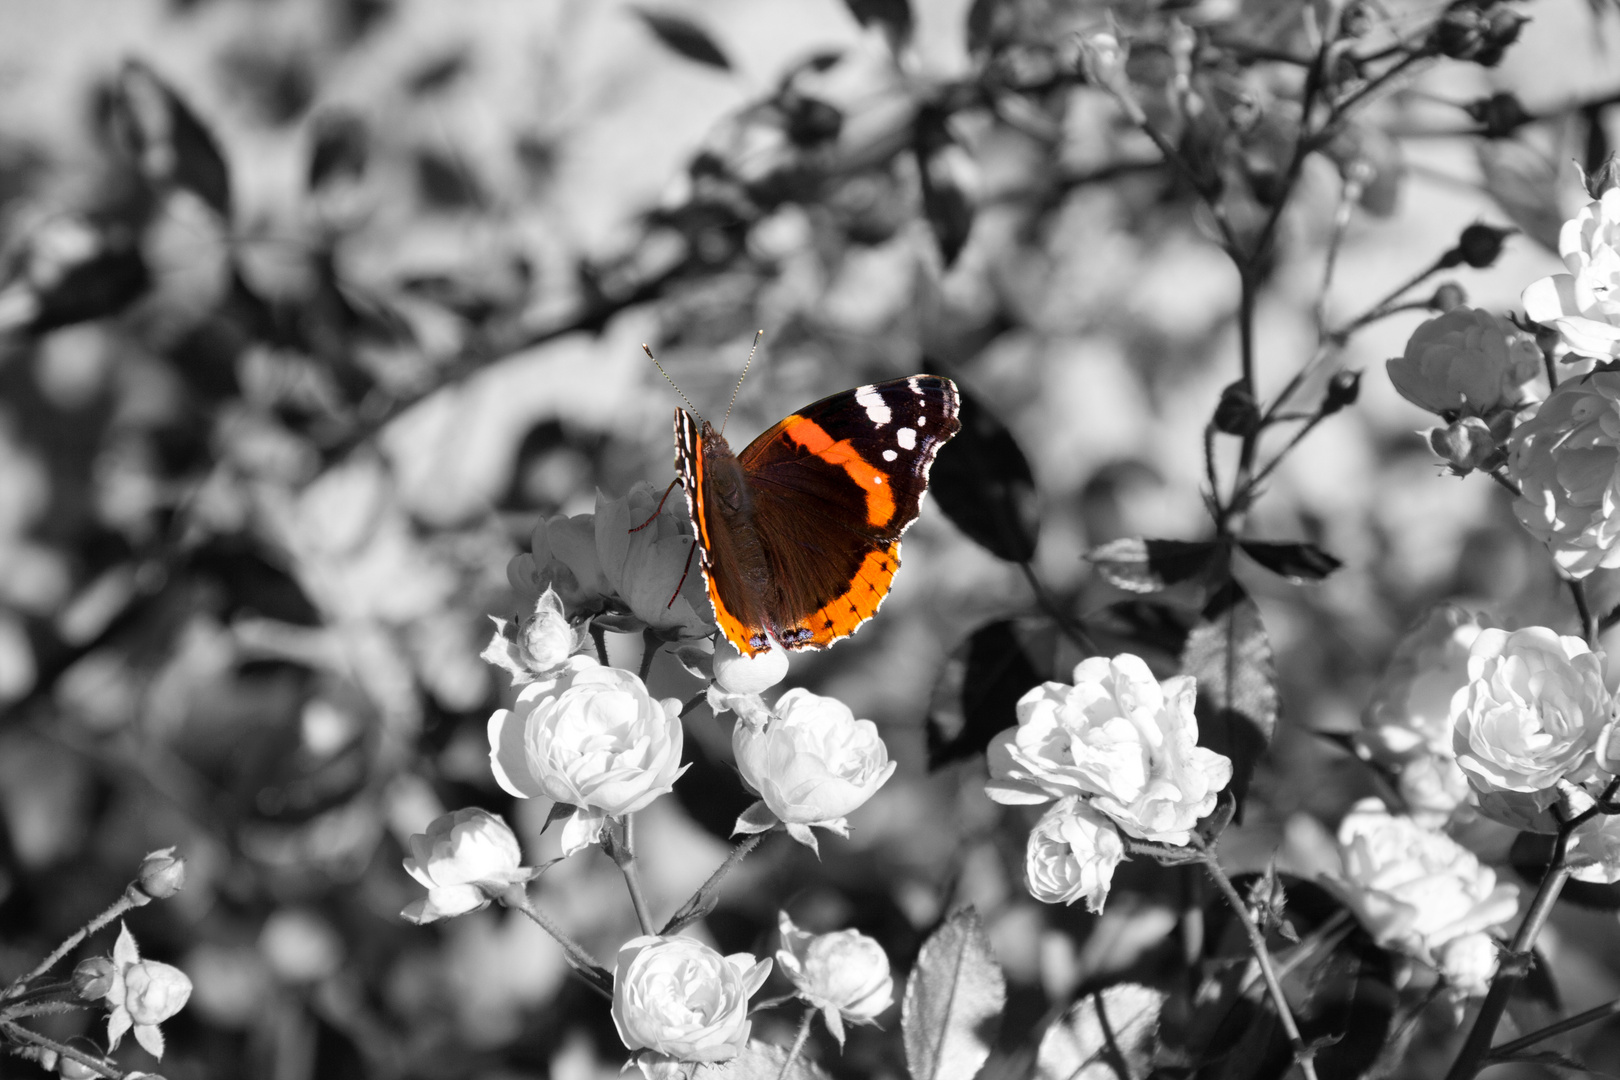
[928,387,1040,562]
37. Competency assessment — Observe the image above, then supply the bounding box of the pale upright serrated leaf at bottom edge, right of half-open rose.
[901,907,1006,1080]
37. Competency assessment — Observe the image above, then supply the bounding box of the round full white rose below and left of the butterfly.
[489,656,685,855]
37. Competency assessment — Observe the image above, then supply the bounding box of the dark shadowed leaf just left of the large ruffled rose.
[927,619,1042,771]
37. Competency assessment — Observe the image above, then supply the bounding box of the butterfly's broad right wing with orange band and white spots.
[738,376,961,649]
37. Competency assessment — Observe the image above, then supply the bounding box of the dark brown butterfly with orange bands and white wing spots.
[676,376,961,656]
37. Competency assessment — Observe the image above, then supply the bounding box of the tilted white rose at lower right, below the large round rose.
[1324,798,1518,963]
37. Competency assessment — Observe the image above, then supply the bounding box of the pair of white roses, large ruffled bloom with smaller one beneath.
[987,653,1231,910]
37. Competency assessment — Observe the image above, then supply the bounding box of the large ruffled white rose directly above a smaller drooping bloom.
[985,653,1231,844]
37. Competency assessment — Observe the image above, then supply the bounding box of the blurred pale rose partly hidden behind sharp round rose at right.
[1354,604,1489,826]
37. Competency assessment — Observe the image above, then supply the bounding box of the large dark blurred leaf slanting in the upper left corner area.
[118,60,230,217]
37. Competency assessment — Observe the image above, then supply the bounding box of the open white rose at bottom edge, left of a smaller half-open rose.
[612,936,771,1077]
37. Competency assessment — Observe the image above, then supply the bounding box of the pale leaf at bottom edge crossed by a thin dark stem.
[1035,983,1170,1080]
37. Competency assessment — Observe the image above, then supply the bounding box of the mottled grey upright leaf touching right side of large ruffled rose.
[1181,581,1277,818]
